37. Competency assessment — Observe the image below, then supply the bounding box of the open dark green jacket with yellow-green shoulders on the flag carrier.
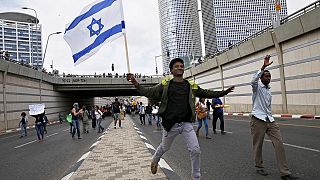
[136,78,225,126]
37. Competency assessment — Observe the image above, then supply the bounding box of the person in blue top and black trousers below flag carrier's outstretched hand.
[212,98,226,135]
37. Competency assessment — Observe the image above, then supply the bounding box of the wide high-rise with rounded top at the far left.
[0,12,42,67]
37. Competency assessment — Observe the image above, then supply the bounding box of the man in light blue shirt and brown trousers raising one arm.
[250,55,298,180]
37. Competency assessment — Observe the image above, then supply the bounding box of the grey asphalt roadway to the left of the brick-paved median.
[0,118,111,180]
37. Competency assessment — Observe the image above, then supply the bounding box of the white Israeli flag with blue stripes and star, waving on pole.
[63,0,125,65]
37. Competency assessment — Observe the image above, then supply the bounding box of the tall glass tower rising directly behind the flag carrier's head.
[159,0,201,74]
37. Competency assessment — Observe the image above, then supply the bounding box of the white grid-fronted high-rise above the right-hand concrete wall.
[211,0,288,50]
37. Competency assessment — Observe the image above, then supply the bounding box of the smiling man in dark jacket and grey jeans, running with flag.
[127,58,234,179]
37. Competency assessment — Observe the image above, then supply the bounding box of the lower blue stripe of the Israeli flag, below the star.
[72,21,124,63]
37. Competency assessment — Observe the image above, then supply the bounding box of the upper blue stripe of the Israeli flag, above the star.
[65,0,117,33]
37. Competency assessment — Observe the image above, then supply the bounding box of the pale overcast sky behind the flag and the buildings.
[0,0,315,75]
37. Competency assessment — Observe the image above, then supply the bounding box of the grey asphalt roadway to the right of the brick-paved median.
[134,116,320,180]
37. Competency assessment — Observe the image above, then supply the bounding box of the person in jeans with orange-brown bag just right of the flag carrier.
[196,97,211,139]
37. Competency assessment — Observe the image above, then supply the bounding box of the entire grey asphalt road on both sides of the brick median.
[0,116,320,180]
